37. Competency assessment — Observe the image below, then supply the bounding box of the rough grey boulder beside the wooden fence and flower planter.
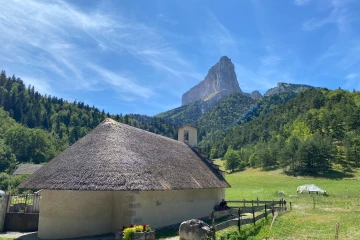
[179,219,211,240]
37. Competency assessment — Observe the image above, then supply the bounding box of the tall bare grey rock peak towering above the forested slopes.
[182,56,242,106]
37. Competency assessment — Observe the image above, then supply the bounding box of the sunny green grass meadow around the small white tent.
[216,160,360,239]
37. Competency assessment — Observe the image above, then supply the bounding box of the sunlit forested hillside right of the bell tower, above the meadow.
[211,89,360,174]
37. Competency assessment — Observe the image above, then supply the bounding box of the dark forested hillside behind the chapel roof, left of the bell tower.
[0,71,177,176]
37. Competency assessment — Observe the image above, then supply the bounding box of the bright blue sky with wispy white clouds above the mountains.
[0,0,360,115]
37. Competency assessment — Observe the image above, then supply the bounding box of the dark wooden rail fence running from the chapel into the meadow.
[210,199,291,231]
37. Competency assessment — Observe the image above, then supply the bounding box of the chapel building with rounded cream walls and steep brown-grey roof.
[20,119,229,239]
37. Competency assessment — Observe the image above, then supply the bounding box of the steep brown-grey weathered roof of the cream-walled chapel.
[19,119,229,191]
